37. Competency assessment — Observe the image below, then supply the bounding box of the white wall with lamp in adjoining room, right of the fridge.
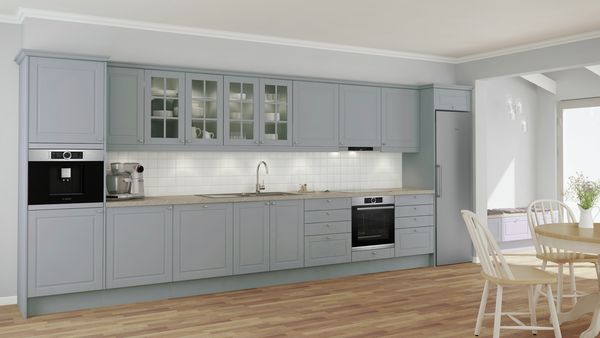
[478,77,538,209]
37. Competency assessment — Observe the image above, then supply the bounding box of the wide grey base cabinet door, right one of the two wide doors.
[173,203,233,281]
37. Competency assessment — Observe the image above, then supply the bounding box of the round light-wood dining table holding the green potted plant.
[535,223,600,338]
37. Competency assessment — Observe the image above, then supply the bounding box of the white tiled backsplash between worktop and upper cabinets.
[107,151,402,196]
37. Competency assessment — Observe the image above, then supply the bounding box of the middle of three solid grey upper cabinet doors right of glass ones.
[340,85,381,147]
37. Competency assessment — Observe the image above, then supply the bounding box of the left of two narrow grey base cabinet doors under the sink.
[233,202,269,274]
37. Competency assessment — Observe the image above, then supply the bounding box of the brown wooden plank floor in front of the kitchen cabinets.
[0,257,596,338]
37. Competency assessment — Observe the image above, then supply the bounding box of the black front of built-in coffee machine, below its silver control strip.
[28,161,104,205]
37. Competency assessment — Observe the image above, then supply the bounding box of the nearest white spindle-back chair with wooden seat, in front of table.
[461,210,562,338]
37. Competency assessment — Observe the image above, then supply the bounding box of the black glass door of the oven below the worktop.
[352,204,394,248]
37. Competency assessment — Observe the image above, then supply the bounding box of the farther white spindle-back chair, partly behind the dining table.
[527,199,600,311]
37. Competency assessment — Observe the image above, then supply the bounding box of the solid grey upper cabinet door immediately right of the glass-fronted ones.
[293,81,339,147]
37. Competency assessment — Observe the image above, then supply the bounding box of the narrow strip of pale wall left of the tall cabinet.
[0,24,21,297]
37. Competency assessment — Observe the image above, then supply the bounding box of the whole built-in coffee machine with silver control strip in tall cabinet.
[28,149,104,209]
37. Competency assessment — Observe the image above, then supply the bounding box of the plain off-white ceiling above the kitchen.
[0,0,600,58]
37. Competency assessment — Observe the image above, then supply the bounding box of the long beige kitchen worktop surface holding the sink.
[106,188,434,208]
